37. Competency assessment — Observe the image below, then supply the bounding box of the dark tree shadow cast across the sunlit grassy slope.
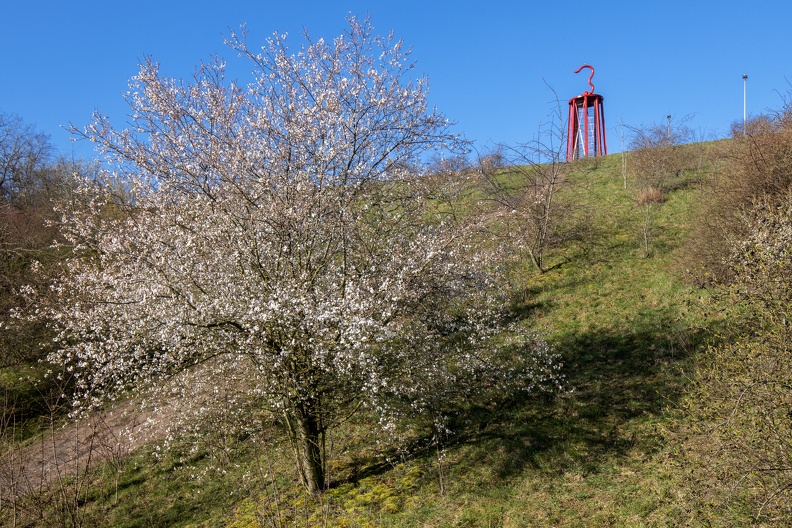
[344,309,707,486]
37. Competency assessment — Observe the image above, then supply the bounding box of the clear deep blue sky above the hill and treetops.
[0,0,792,158]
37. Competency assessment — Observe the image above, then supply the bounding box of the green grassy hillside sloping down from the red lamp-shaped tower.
[0,146,736,527]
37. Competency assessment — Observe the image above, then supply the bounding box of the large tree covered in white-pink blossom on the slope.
[41,18,557,492]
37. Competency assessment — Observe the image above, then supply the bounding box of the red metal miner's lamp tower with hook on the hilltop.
[567,64,608,161]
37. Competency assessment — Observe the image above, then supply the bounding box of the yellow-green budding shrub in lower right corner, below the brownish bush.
[685,193,792,526]
